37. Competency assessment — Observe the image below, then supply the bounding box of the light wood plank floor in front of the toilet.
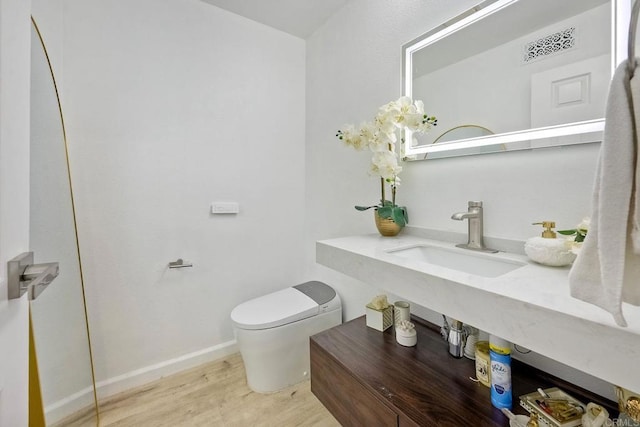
[59,354,340,427]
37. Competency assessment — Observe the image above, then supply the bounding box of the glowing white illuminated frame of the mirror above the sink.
[401,0,640,161]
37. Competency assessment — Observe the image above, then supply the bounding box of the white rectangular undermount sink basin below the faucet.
[386,244,527,277]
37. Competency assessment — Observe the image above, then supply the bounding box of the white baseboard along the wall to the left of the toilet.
[96,340,238,402]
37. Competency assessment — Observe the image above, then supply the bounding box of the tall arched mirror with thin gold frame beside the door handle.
[29,20,97,425]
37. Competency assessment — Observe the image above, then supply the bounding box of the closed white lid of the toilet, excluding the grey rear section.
[231,288,319,329]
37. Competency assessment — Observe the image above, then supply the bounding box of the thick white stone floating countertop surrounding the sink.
[316,233,640,392]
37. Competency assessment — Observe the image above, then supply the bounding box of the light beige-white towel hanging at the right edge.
[569,61,640,326]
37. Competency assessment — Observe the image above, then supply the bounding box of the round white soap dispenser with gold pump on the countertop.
[524,221,576,267]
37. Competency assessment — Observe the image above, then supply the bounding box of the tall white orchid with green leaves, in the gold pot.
[336,96,438,227]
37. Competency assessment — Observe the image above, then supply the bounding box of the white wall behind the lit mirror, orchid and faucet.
[306,0,610,398]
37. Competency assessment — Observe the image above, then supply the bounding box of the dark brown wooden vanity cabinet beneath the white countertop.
[310,317,615,427]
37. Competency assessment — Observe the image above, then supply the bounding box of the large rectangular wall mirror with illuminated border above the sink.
[403,0,629,160]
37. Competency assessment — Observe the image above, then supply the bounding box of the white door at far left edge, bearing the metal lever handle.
[0,0,30,427]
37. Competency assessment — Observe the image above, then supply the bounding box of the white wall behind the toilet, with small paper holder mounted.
[62,0,305,394]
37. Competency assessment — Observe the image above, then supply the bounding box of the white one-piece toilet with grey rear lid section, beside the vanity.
[231,281,342,393]
